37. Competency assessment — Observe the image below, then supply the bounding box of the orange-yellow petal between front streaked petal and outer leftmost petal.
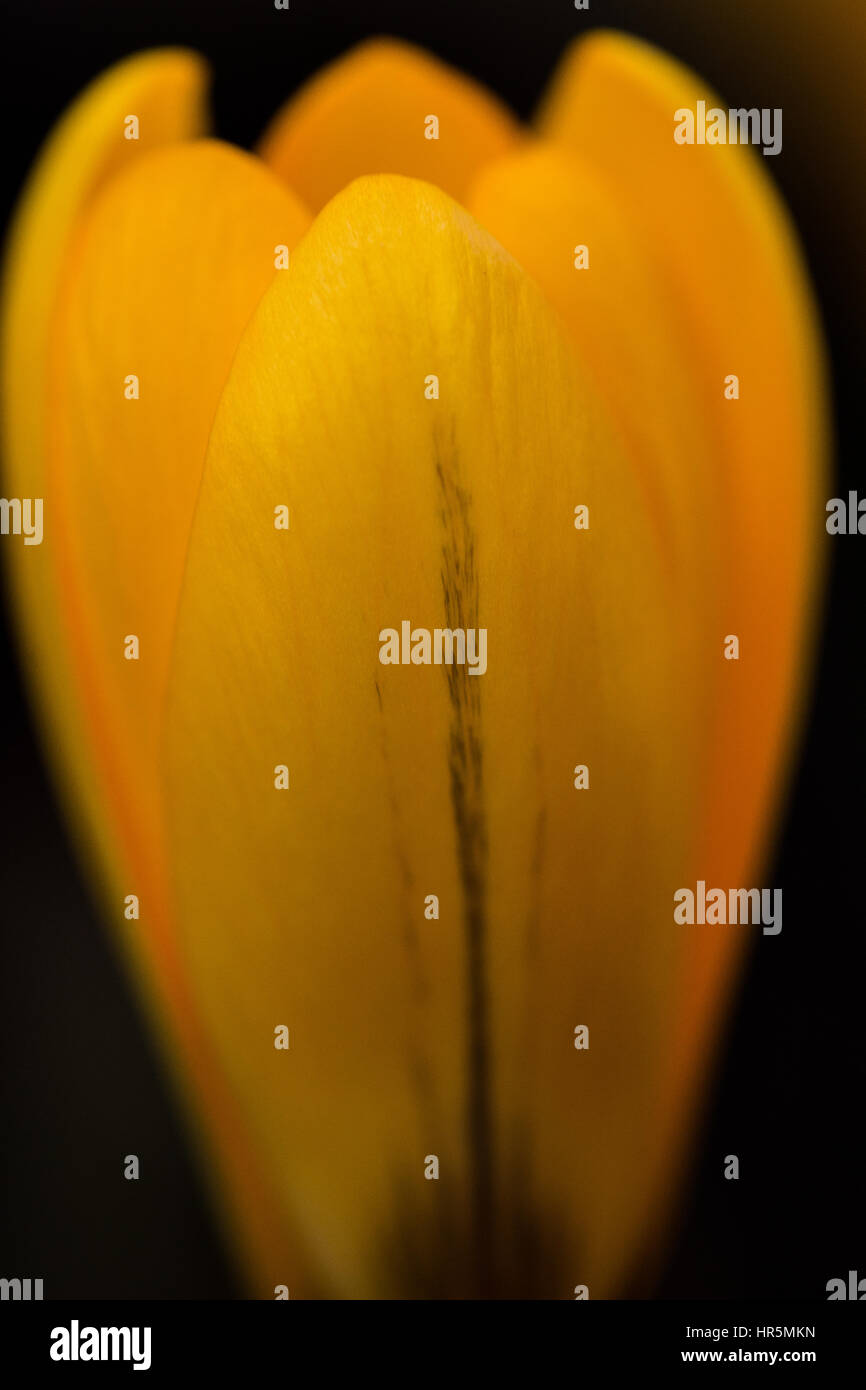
[46,140,309,1289]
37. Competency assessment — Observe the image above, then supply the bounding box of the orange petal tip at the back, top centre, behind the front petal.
[259,39,518,211]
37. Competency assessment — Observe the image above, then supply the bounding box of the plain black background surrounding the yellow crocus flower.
[0,0,866,1298]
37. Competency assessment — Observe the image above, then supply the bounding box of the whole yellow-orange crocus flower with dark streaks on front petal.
[1,32,827,1298]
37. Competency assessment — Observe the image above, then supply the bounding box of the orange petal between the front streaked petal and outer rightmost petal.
[466,142,719,608]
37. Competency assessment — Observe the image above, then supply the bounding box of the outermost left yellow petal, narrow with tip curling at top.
[0,49,206,889]
